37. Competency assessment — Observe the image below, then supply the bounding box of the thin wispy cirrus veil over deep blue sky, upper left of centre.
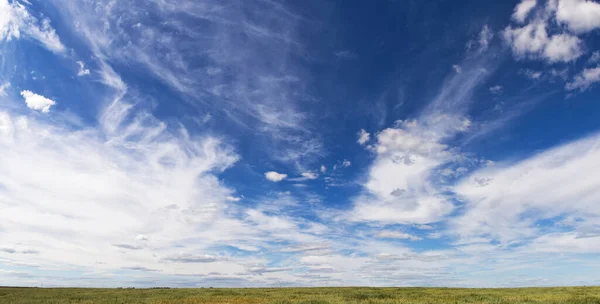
[53,0,324,167]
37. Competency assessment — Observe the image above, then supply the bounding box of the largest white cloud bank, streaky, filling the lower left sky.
[0,107,246,272]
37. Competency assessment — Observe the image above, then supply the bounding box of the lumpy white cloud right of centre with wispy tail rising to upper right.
[345,54,489,224]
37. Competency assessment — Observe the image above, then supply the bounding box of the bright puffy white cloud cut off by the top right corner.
[556,0,600,33]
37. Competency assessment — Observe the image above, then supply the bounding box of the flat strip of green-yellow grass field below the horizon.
[0,287,600,304]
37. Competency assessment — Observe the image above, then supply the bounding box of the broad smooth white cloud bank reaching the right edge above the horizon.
[450,134,600,244]
